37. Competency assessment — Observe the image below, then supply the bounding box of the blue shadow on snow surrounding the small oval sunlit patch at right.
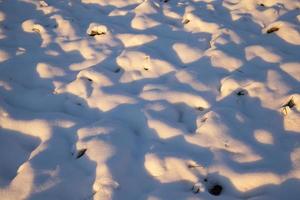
[211,92,300,175]
